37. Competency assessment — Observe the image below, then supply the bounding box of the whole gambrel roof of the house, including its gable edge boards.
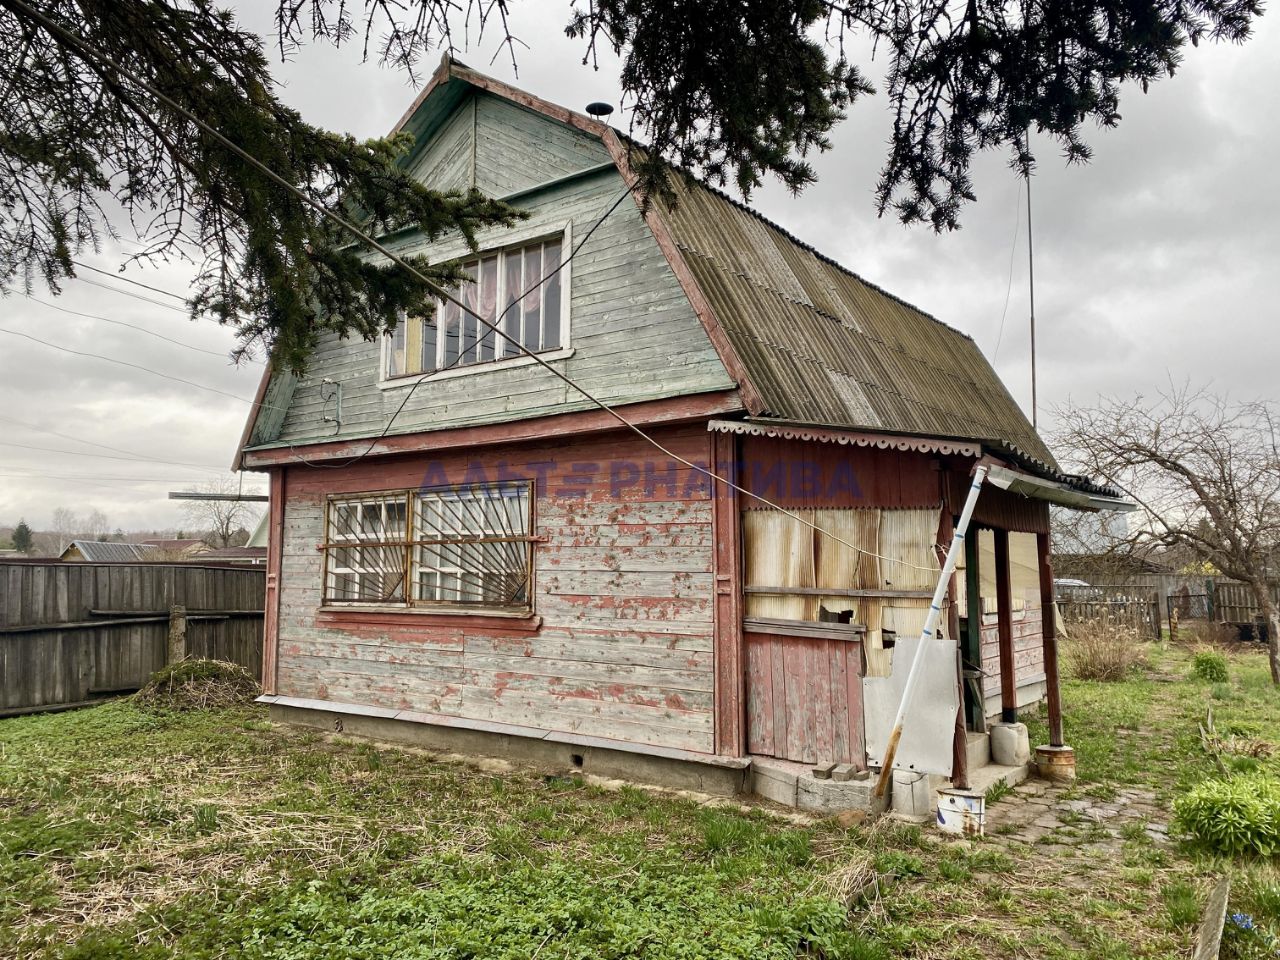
[236,56,1075,490]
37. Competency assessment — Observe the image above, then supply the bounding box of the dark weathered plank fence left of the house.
[0,561,266,716]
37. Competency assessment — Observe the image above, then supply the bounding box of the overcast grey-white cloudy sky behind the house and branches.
[0,0,1280,530]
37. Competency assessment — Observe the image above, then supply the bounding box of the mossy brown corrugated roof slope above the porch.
[654,178,1057,472]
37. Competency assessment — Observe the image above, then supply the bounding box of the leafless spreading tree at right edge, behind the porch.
[1059,385,1280,684]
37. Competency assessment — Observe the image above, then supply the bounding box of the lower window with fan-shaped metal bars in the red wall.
[323,480,534,612]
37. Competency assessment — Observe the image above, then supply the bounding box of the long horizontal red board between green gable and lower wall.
[243,390,742,468]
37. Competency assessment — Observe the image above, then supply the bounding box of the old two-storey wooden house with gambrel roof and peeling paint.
[237,59,1117,809]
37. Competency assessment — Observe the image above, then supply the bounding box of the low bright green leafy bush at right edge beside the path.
[1174,774,1280,856]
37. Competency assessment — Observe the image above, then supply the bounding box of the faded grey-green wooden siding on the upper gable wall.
[252,96,735,445]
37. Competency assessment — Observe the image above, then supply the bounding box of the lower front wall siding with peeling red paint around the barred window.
[276,426,714,753]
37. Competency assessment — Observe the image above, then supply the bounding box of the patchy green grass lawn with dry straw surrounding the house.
[0,640,1280,960]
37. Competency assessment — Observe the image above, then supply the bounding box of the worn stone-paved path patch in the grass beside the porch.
[987,780,1169,850]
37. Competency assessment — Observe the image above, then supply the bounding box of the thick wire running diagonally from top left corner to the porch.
[5,0,937,573]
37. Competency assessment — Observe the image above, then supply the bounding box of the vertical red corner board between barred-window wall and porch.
[707,433,746,756]
